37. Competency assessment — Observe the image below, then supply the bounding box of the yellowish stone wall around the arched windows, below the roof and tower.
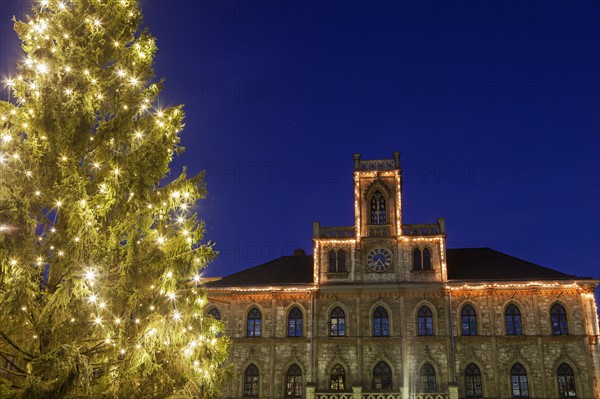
[207,284,599,398]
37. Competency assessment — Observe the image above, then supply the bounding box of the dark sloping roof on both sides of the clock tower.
[206,248,578,288]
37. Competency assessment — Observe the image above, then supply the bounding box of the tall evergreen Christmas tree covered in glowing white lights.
[0,0,228,399]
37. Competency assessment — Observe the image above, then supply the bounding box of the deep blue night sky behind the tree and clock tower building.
[0,0,600,288]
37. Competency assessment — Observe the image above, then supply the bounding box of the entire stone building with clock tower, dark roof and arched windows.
[206,153,600,399]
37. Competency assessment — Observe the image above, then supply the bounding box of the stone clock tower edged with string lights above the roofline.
[313,152,447,284]
